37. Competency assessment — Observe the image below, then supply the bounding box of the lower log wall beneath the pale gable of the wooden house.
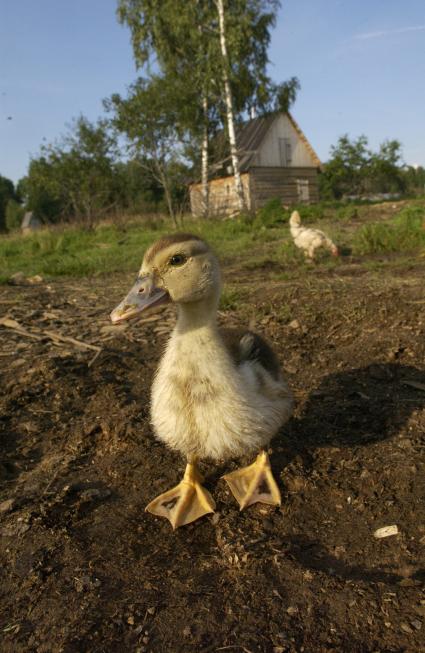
[249,167,319,210]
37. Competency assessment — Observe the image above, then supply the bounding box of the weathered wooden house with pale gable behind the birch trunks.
[189,113,321,216]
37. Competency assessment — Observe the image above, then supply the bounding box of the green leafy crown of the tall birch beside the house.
[117,0,282,117]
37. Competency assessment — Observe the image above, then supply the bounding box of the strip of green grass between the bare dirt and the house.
[0,203,425,280]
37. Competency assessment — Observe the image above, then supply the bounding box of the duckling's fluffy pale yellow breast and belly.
[151,330,292,459]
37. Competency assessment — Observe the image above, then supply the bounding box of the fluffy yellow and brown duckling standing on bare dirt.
[111,233,293,529]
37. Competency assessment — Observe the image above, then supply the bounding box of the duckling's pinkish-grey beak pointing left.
[111,275,171,324]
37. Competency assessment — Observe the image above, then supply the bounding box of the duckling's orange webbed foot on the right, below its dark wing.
[223,451,281,510]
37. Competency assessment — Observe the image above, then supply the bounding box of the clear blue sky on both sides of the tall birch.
[0,0,425,181]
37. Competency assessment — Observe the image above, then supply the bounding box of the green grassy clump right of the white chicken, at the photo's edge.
[353,207,425,254]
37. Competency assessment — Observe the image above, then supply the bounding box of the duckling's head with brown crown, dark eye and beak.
[111,234,221,323]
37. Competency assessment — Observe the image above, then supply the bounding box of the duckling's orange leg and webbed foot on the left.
[145,458,215,530]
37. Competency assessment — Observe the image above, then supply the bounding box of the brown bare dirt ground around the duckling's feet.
[0,251,425,653]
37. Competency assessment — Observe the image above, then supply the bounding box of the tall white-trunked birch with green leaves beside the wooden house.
[118,0,279,213]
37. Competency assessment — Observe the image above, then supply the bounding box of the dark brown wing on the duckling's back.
[219,329,280,380]
